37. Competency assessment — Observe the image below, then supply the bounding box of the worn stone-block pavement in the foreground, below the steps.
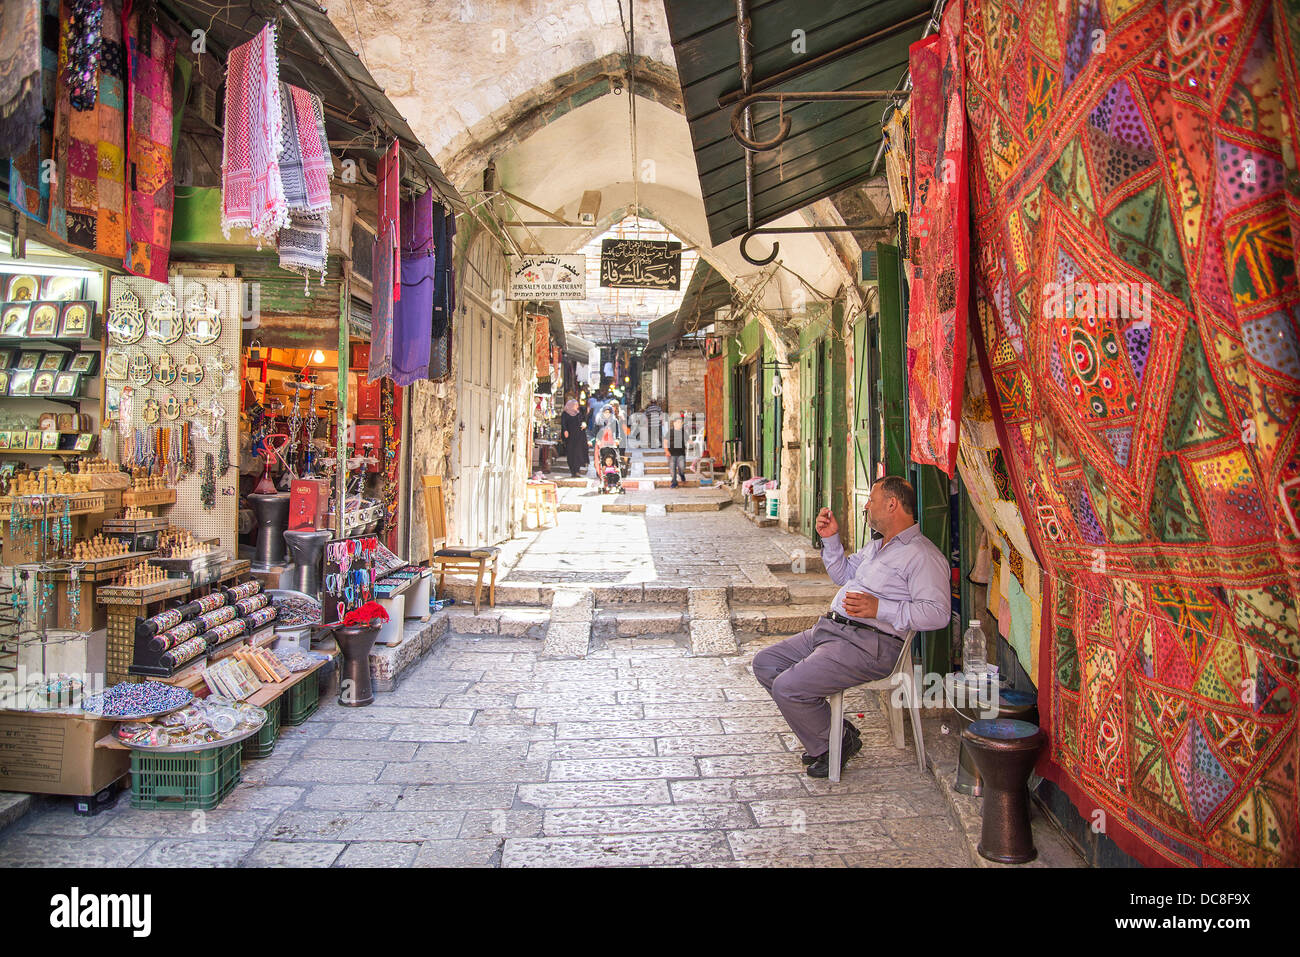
[0,636,993,867]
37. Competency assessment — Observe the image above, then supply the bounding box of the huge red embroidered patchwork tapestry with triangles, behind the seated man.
[963,0,1300,866]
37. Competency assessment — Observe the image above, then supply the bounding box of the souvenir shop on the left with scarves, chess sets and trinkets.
[0,0,464,813]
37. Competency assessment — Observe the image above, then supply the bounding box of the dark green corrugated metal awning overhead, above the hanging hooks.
[664,0,931,246]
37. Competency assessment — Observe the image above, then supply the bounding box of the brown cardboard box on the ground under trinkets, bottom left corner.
[0,711,131,796]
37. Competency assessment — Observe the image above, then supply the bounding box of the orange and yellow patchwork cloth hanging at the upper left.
[49,0,126,259]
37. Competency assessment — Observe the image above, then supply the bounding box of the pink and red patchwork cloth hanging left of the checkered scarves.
[124,10,176,282]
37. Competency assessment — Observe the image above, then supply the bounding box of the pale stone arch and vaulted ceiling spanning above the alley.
[326,0,889,313]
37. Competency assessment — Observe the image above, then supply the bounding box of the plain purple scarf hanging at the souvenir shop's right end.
[393,190,437,385]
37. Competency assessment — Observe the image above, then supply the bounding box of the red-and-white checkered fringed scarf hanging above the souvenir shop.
[221,23,289,248]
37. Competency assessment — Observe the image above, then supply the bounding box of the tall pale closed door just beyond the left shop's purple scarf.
[450,234,523,545]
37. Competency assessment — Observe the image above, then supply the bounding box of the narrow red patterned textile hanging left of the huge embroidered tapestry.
[907,0,970,476]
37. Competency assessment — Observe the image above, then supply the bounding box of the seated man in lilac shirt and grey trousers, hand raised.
[754,476,952,778]
